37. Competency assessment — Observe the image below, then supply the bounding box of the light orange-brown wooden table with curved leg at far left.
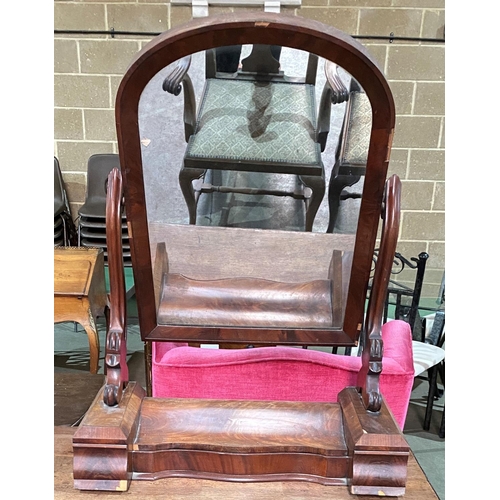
[54,247,108,373]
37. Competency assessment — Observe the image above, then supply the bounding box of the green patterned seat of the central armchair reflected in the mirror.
[185,78,322,173]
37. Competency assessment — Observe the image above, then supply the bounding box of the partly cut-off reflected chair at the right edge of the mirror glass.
[326,79,372,233]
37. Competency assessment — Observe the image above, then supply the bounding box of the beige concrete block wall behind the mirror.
[54,0,445,297]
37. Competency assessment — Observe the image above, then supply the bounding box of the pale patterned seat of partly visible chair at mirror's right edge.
[341,92,372,165]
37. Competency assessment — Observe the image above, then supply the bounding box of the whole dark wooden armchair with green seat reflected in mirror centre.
[163,44,348,231]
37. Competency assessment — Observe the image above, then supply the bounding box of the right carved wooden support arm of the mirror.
[358,175,401,412]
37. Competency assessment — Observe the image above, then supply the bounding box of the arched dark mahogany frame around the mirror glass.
[115,12,395,345]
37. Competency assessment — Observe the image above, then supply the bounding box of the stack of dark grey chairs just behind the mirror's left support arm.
[78,154,132,267]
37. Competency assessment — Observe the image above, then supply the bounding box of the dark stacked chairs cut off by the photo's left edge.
[54,156,76,247]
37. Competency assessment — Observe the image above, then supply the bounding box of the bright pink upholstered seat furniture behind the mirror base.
[152,321,414,429]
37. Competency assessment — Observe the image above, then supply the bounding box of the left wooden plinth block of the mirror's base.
[73,382,145,491]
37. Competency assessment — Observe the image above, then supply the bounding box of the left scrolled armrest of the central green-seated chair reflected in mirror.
[163,56,196,142]
